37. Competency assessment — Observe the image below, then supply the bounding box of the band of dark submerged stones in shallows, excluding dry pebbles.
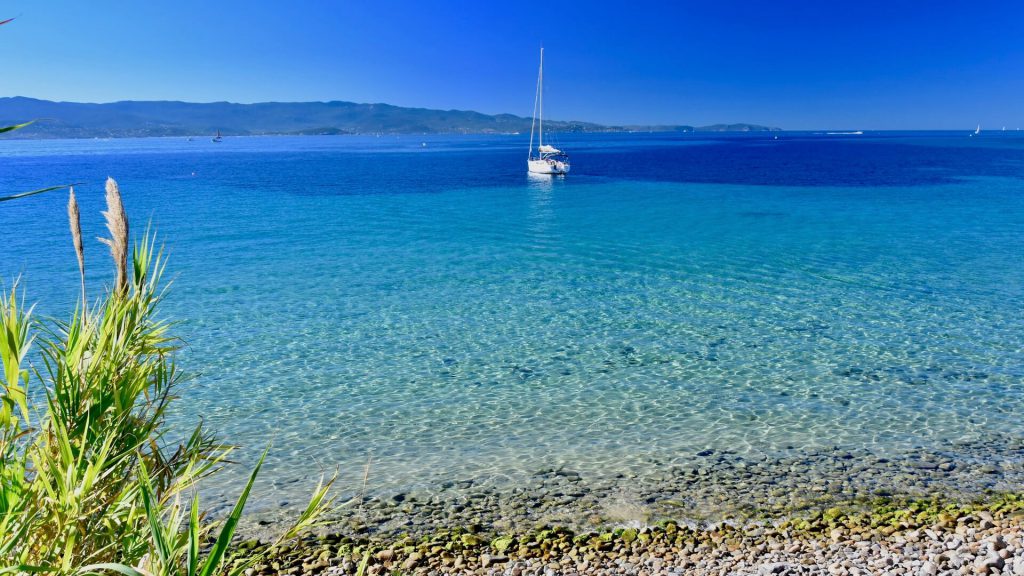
[246,436,1024,539]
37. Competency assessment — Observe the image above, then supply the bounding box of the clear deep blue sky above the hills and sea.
[0,0,1024,129]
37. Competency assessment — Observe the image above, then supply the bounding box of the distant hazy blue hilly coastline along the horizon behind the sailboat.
[0,96,780,139]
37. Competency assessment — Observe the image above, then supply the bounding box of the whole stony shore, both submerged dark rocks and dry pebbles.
[235,436,1024,576]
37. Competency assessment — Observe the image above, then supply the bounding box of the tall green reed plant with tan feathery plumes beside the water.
[0,179,336,576]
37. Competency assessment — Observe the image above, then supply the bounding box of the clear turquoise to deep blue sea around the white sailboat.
[0,133,1024,520]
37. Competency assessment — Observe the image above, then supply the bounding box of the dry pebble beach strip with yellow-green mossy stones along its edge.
[241,494,1024,576]
